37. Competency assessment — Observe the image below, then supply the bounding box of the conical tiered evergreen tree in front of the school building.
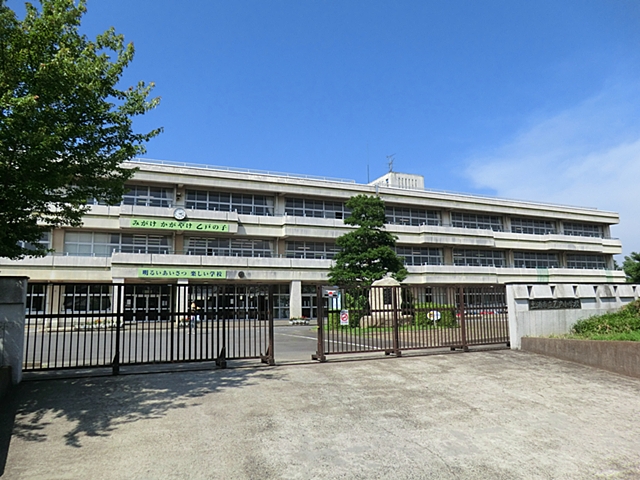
[329,195,407,286]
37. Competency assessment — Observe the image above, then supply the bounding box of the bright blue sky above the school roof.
[8,0,640,254]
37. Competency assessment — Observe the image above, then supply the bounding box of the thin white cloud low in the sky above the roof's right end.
[466,86,640,255]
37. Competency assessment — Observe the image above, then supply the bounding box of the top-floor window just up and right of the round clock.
[185,190,273,215]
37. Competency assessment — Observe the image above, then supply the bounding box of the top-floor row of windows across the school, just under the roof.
[96,185,604,237]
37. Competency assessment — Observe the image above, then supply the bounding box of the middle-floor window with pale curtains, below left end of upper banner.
[64,232,171,257]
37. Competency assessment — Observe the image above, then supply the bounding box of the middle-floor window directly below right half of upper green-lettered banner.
[186,237,273,257]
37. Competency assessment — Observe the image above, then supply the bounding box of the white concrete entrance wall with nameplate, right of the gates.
[507,283,640,349]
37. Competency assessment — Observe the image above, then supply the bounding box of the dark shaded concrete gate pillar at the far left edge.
[0,277,28,383]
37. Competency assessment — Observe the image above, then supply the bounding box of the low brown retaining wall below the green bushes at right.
[522,337,640,378]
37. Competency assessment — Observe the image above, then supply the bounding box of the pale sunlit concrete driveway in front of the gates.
[0,350,640,480]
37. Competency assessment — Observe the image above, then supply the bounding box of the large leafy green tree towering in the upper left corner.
[0,0,161,258]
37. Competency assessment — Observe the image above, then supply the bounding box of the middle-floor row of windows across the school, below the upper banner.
[58,232,606,269]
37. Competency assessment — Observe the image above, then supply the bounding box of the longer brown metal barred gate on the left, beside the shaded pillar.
[24,284,274,374]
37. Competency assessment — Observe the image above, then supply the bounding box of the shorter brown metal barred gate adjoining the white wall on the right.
[313,285,509,361]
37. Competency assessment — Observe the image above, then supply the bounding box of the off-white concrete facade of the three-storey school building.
[0,161,624,320]
